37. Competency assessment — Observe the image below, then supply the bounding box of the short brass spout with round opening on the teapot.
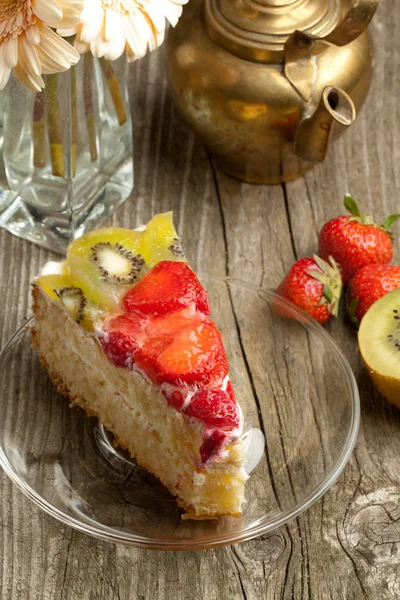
[294,86,356,163]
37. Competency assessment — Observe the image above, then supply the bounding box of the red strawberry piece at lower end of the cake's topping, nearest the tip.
[184,382,239,427]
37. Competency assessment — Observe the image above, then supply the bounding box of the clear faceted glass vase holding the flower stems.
[0,53,133,253]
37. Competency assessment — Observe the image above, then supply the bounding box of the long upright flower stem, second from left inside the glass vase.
[46,73,64,177]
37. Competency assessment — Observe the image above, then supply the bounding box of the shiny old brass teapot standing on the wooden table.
[167,0,380,184]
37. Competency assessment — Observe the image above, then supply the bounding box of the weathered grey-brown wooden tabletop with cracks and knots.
[0,0,400,600]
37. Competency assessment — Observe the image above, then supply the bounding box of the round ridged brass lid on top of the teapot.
[205,0,342,62]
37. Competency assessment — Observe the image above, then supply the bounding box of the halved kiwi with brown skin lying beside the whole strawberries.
[358,289,400,407]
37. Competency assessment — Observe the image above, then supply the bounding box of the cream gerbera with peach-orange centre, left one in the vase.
[0,0,83,92]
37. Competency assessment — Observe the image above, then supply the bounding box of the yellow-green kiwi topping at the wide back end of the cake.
[36,212,185,328]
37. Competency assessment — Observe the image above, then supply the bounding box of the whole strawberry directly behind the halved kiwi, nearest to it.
[347,265,400,327]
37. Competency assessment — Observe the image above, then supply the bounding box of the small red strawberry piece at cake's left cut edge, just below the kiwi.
[99,315,146,369]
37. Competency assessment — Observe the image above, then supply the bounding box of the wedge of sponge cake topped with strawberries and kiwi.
[32,213,247,519]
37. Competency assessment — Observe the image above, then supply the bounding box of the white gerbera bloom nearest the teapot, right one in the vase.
[59,0,188,62]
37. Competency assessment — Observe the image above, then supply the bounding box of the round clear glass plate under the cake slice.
[0,277,360,550]
